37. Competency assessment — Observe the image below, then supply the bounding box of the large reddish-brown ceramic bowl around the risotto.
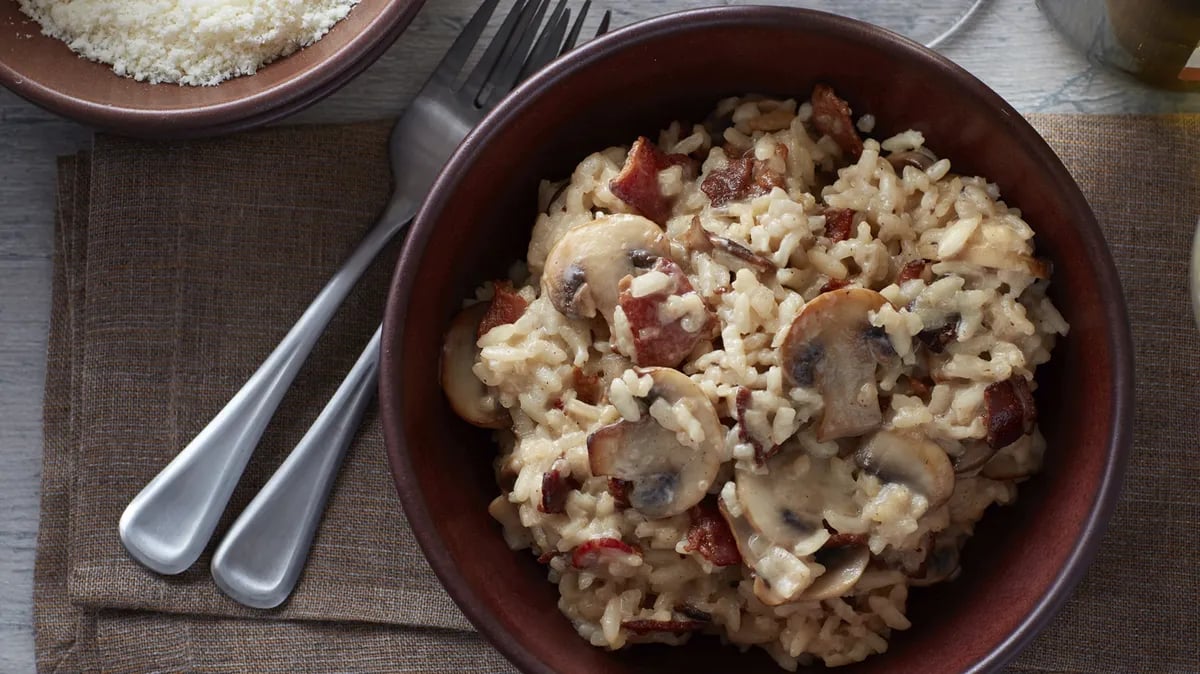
[380,7,1133,674]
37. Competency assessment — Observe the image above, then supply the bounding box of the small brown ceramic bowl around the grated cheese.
[0,0,424,138]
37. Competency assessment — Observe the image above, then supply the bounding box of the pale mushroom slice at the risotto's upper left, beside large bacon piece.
[541,213,670,324]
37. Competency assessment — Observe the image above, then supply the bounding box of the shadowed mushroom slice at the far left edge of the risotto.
[442,302,509,428]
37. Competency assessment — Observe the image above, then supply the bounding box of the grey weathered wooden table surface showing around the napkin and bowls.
[0,0,1200,673]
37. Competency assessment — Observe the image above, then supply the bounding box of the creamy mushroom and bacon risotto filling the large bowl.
[442,85,1068,669]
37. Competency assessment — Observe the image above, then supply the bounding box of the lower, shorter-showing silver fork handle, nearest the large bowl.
[211,329,382,608]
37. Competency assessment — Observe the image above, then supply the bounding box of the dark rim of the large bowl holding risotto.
[379,6,1134,674]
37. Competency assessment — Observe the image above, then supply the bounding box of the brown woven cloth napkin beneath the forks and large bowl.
[34,115,1200,673]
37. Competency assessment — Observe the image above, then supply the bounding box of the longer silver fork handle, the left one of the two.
[119,199,419,574]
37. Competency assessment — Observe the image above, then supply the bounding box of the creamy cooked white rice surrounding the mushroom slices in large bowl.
[446,89,1068,669]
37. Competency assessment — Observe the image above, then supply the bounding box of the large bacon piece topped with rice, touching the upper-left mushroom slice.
[617,258,714,367]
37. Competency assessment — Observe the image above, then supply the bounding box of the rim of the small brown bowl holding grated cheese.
[0,0,425,138]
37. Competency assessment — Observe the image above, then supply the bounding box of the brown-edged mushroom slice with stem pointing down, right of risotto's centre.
[781,288,895,441]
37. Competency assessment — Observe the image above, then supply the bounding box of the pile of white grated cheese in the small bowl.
[18,0,358,85]
